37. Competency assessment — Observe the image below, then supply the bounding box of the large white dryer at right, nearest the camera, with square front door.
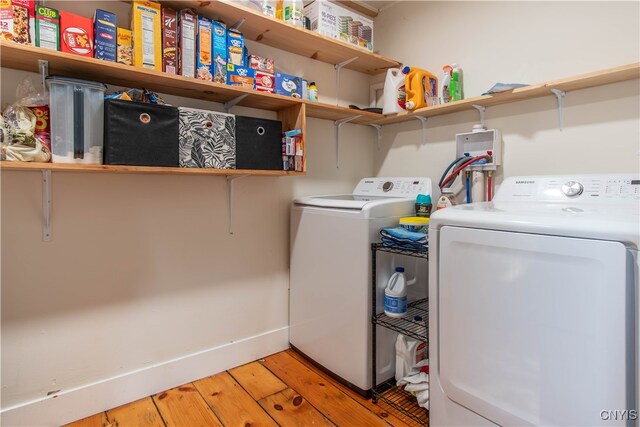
[429,174,640,426]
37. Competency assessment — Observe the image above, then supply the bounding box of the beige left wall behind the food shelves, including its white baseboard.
[0,1,375,425]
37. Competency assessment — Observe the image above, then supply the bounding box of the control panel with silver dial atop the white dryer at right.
[493,174,640,205]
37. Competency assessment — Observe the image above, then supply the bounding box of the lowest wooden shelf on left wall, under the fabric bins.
[0,161,305,176]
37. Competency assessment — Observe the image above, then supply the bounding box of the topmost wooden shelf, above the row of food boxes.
[161,0,400,75]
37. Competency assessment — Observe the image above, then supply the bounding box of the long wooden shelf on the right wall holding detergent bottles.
[376,63,640,125]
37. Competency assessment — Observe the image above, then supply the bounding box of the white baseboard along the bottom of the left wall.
[0,327,289,426]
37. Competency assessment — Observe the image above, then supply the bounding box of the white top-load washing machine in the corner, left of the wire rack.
[289,178,432,395]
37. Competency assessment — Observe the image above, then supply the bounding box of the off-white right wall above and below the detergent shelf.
[375,1,640,193]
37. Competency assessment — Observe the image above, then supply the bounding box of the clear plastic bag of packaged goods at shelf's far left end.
[0,77,51,162]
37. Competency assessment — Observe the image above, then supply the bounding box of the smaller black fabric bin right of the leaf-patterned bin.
[236,116,282,170]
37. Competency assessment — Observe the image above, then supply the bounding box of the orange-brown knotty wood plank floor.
[67,350,428,427]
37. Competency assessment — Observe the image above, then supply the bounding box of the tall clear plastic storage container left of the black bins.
[47,76,107,164]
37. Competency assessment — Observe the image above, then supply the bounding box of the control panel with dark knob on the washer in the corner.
[353,177,433,198]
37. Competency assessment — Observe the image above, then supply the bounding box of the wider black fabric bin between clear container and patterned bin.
[104,99,178,167]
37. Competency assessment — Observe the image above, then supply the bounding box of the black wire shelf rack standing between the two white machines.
[371,243,429,425]
